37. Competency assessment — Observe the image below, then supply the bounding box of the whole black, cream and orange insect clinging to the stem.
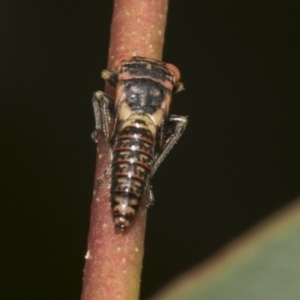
[92,56,187,230]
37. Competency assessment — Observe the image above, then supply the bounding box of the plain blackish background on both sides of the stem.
[0,0,300,300]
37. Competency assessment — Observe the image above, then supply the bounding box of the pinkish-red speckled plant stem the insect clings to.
[81,0,168,300]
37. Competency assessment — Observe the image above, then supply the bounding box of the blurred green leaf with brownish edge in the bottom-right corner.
[151,200,300,300]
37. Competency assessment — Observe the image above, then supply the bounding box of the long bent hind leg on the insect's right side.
[151,115,187,177]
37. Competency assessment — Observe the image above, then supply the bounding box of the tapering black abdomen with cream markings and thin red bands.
[111,116,155,229]
